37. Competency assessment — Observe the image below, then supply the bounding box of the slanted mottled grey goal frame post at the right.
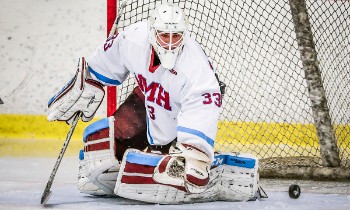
[289,0,340,167]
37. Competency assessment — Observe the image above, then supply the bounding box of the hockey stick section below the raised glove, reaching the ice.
[40,112,81,206]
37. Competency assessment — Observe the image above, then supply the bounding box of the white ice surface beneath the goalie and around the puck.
[0,157,350,210]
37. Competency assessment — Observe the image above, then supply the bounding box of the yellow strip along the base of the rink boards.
[0,114,350,157]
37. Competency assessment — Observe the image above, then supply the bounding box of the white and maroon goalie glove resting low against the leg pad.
[153,142,211,193]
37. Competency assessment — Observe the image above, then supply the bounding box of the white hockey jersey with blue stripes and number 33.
[87,22,221,160]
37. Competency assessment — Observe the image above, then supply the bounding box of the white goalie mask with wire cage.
[148,4,188,70]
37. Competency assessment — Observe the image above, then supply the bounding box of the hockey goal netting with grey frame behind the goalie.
[110,0,350,180]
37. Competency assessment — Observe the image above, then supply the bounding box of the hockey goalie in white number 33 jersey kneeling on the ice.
[48,4,266,204]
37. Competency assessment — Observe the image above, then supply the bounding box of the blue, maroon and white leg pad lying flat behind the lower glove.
[114,149,258,204]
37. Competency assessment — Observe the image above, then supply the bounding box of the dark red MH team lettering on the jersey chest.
[136,74,171,111]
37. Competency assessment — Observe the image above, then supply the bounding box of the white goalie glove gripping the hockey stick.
[47,58,105,124]
